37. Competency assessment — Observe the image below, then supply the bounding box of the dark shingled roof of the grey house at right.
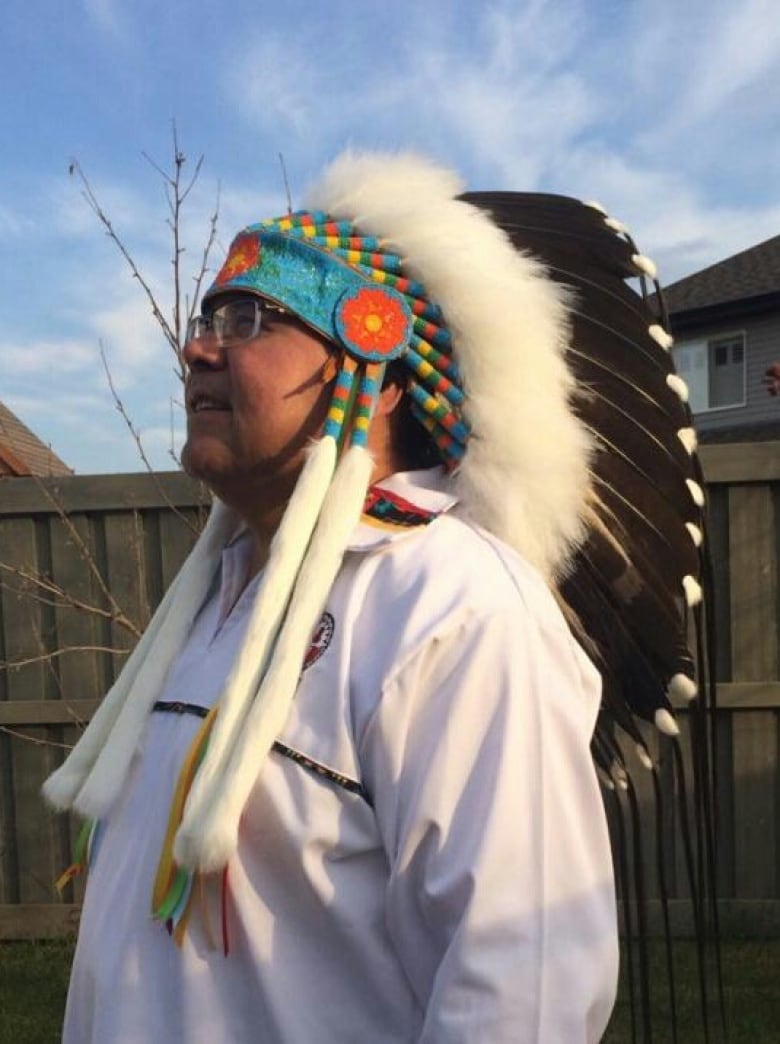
[663,236,780,315]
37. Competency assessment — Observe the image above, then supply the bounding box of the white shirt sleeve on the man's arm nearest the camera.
[361,610,617,1044]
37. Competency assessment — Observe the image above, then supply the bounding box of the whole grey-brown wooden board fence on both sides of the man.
[0,443,780,940]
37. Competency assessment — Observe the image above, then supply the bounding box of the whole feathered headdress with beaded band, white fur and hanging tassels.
[45,153,711,1031]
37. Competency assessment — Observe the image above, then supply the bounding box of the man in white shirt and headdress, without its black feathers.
[47,155,705,1044]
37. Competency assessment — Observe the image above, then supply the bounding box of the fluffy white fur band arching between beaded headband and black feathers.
[307,152,591,578]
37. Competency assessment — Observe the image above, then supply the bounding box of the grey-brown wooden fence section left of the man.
[0,473,205,939]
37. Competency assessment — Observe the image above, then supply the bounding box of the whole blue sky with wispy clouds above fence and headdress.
[0,0,780,473]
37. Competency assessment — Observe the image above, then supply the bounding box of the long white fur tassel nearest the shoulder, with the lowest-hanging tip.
[173,447,373,873]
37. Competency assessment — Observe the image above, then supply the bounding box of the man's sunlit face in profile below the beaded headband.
[182,294,332,496]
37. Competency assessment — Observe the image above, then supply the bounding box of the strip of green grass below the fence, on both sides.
[0,940,780,1044]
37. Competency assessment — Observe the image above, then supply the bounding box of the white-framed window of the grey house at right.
[675,333,746,413]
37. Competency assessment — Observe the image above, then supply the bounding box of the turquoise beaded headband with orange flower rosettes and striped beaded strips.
[204,211,469,469]
